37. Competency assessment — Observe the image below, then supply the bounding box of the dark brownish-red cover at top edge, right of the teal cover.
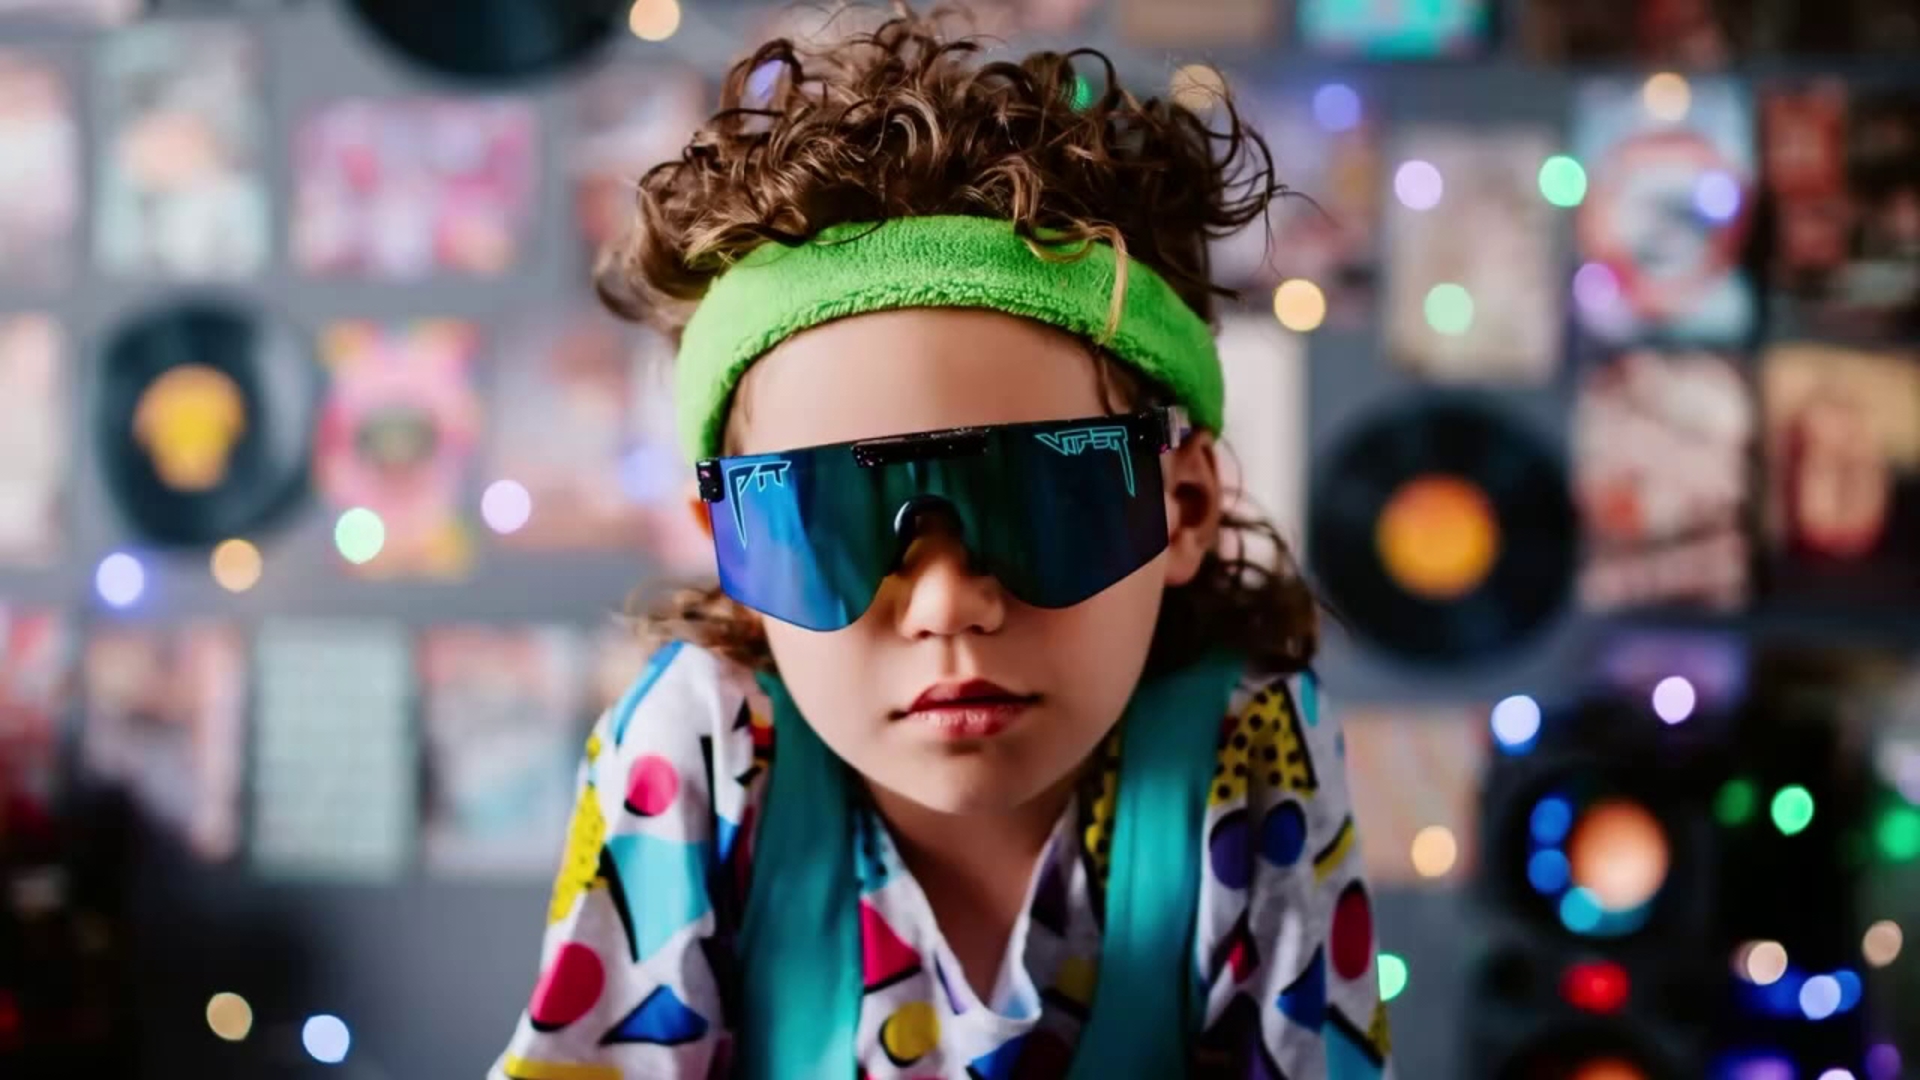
[1521,0,1759,71]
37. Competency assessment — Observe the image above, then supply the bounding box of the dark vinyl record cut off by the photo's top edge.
[348,0,632,83]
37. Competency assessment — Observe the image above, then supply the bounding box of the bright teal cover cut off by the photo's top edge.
[1298,0,1492,60]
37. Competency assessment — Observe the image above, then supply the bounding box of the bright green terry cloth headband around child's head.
[674,217,1227,461]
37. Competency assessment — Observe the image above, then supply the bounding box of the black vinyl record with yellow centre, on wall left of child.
[94,300,321,546]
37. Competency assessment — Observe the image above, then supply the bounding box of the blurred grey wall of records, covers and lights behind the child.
[0,0,1920,1080]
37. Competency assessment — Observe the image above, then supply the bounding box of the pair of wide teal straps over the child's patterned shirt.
[733,655,1242,1080]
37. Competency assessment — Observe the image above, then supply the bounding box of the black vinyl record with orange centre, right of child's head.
[1309,396,1576,663]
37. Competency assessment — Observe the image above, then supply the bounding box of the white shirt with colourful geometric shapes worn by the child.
[490,646,1390,1080]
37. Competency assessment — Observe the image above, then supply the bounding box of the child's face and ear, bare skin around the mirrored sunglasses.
[728,309,1219,813]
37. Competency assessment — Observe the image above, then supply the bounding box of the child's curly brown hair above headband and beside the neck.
[595,4,1317,673]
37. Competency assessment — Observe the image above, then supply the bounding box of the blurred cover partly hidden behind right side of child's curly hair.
[1213,83,1380,329]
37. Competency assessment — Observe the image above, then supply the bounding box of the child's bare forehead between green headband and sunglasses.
[728,309,1104,454]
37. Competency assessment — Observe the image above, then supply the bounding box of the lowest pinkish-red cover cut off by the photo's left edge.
[0,605,73,836]
